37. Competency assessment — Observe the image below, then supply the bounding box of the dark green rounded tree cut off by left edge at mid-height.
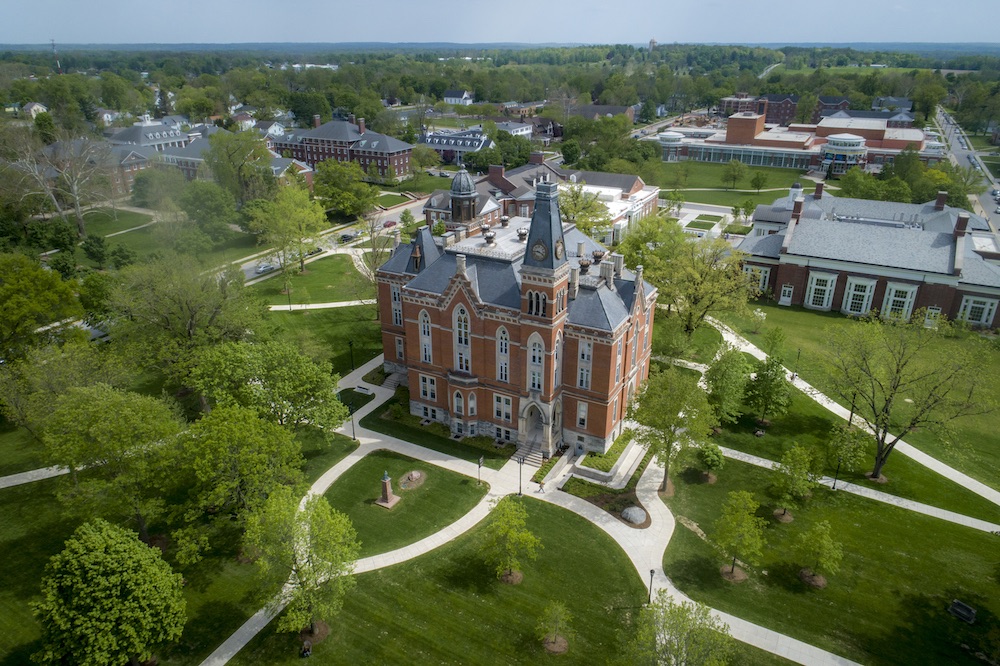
[0,254,83,361]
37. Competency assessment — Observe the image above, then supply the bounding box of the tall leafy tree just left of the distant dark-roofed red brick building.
[205,132,276,204]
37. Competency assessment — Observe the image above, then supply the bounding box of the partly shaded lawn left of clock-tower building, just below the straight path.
[268,305,382,376]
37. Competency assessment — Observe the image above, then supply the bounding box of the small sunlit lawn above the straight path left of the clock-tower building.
[250,254,375,305]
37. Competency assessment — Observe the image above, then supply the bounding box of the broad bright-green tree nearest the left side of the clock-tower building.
[191,341,348,431]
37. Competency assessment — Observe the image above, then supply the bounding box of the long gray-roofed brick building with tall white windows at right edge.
[738,183,1000,328]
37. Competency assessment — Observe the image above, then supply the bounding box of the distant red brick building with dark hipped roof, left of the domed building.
[273,116,413,180]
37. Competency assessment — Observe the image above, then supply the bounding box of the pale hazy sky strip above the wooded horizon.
[7,0,998,44]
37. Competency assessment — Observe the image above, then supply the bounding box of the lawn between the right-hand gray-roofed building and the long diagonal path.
[724,301,1000,488]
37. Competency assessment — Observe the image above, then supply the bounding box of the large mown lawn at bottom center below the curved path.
[230,499,648,665]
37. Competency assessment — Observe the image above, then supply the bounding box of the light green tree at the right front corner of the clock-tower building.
[630,365,715,490]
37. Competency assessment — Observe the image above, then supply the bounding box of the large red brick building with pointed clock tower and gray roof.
[377,179,657,456]
